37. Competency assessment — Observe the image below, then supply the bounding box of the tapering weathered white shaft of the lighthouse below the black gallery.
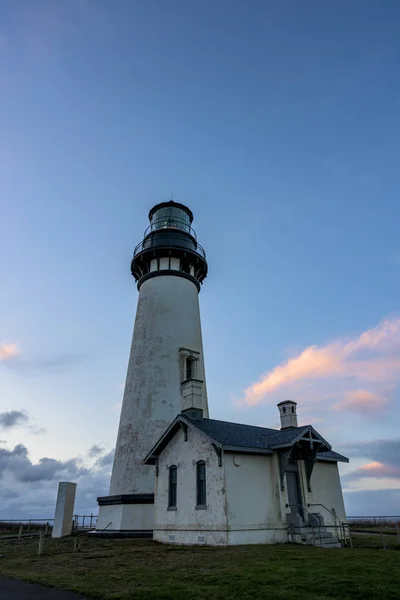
[109,275,208,496]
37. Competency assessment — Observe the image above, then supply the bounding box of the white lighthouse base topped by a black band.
[96,494,154,537]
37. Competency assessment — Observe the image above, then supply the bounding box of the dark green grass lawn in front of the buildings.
[0,536,400,600]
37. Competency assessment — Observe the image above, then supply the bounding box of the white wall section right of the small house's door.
[307,461,346,525]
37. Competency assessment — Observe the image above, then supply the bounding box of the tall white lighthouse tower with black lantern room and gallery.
[97,201,208,536]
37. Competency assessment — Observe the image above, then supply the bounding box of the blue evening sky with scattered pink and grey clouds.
[0,0,400,518]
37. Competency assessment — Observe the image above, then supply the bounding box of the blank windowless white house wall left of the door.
[224,453,287,544]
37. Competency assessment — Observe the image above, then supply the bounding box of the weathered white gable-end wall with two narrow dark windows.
[154,427,227,545]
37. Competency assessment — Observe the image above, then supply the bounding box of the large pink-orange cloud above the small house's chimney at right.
[242,318,400,415]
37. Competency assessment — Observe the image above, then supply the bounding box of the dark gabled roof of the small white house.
[145,415,348,464]
